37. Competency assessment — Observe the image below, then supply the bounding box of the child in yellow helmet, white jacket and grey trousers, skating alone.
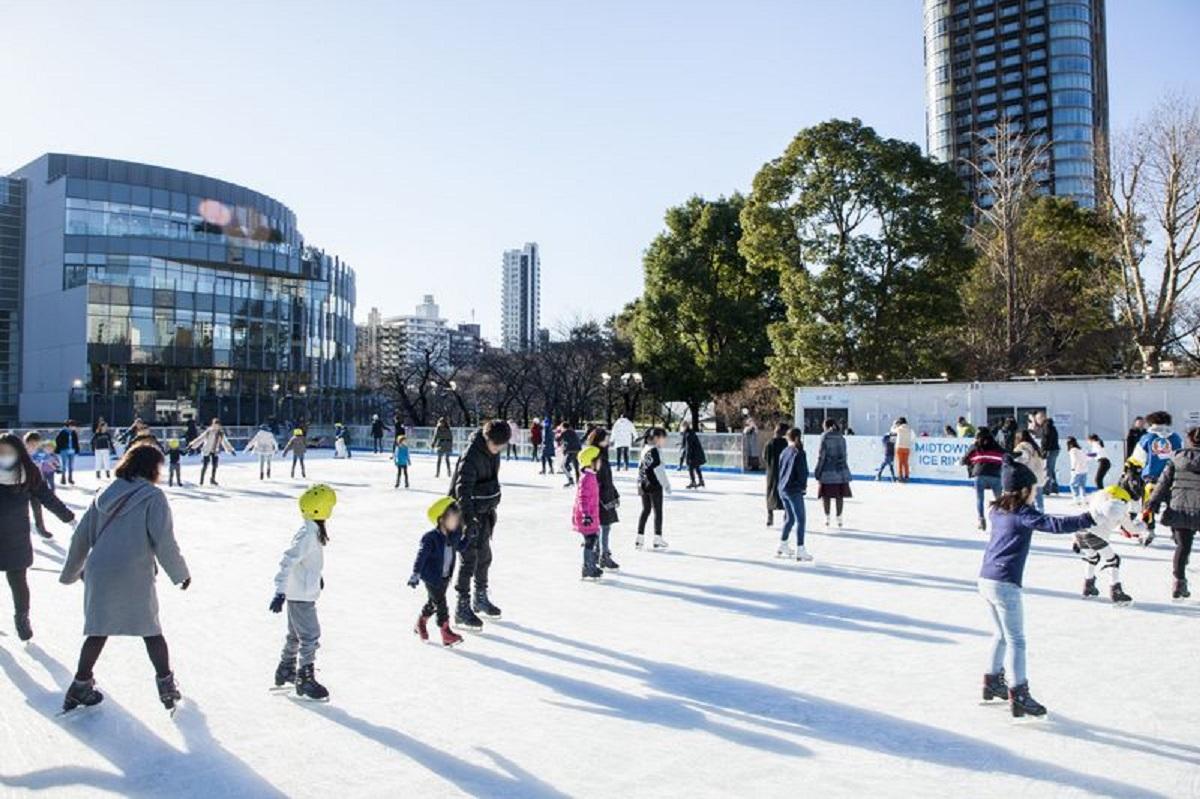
[270,483,337,701]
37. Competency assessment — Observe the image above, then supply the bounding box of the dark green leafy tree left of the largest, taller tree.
[631,194,781,425]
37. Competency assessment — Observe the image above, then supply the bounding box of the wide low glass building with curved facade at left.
[0,154,355,423]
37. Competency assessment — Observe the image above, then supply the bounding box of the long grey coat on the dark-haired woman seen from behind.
[59,477,191,637]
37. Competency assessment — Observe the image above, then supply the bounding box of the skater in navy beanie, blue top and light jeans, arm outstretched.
[977,453,1117,717]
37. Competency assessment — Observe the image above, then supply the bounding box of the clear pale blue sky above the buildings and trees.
[0,0,1200,337]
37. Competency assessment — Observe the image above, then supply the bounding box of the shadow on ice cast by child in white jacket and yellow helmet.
[292,703,568,799]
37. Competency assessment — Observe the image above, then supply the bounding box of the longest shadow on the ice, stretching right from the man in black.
[488,623,1163,798]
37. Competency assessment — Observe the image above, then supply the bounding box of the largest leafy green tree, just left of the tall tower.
[742,119,970,396]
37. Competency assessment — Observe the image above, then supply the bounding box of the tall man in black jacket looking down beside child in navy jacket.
[450,420,512,630]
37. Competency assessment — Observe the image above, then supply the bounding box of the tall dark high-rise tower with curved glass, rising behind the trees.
[924,0,1109,208]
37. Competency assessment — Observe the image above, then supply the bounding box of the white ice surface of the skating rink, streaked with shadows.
[0,453,1200,799]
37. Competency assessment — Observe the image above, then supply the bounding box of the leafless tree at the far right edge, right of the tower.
[1099,96,1200,371]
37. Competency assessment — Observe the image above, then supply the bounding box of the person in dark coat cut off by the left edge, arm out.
[0,433,74,641]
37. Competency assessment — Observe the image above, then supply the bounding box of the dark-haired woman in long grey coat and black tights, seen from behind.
[59,446,192,710]
